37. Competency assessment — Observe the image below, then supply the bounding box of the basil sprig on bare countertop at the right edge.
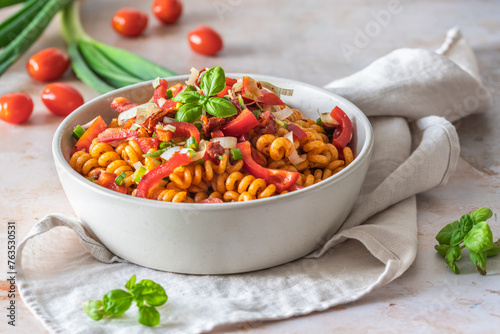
[434,208,500,275]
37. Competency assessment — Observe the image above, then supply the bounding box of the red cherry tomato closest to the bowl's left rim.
[42,82,83,116]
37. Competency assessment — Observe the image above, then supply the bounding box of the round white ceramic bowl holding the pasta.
[52,73,373,274]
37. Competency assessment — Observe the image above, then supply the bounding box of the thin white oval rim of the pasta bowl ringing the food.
[52,73,374,211]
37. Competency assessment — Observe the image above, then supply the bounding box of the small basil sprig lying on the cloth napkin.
[83,275,168,327]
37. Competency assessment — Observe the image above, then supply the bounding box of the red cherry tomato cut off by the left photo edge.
[0,93,33,124]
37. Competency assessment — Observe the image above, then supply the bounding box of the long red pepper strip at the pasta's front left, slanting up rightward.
[135,154,193,198]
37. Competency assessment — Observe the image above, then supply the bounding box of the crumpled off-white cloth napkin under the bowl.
[17,29,491,333]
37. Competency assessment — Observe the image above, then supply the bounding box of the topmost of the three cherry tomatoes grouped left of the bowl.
[26,48,70,82]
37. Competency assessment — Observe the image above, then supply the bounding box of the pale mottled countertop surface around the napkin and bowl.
[0,0,500,333]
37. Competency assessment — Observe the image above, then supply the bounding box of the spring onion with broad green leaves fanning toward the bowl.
[60,0,175,93]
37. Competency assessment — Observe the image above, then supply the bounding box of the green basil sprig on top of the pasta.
[172,66,238,123]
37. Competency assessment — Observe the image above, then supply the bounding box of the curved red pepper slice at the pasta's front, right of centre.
[236,141,300,193]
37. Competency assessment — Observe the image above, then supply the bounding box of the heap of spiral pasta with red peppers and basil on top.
[71,67,354,203]
